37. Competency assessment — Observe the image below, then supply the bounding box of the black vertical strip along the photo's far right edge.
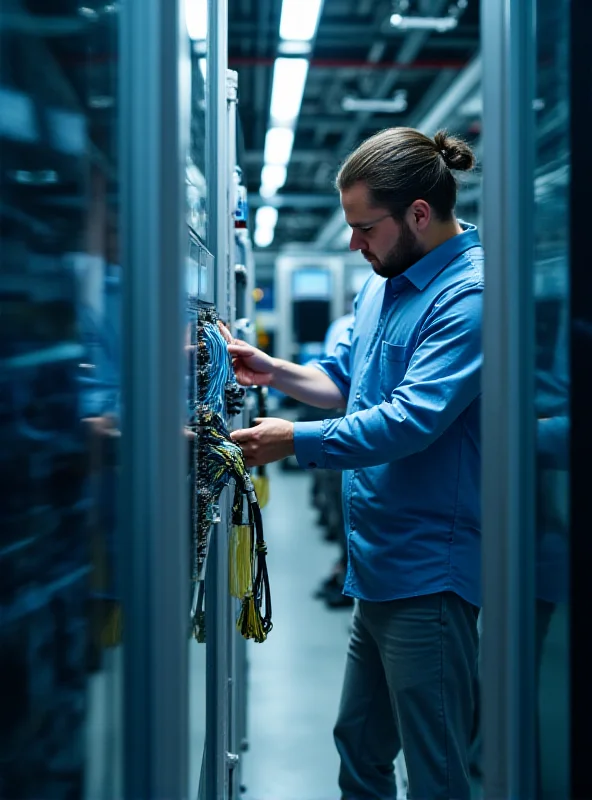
[568,0,592,800]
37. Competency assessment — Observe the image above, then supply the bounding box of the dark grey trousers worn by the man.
[334,592,479,800]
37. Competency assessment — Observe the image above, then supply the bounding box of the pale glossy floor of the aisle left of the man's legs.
[243,467,351,800]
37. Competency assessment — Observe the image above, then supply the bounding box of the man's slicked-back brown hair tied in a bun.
[336,128,475,221]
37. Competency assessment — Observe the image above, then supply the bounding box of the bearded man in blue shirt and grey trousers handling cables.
[229,128,483,800]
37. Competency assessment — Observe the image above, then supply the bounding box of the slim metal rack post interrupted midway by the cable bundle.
[203,0,231,800]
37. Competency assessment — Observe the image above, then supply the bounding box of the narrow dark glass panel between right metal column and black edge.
[534,0,570,800]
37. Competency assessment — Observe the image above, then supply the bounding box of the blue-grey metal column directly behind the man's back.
[481,0,536,800]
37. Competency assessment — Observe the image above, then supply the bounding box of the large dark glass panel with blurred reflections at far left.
[0,0,122,800]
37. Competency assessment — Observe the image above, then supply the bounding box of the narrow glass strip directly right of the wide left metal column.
[185,0,210,798]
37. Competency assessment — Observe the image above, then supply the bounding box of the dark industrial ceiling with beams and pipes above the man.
[229,0,481,250]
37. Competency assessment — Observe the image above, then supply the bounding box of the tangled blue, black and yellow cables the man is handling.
[190,307,272,642]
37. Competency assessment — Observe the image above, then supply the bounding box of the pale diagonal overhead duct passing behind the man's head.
[314,56,481,250]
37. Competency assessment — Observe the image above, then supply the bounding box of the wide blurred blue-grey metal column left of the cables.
[119,0,189,800]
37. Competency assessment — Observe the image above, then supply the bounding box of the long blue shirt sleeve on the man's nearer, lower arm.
[294,284,482,470]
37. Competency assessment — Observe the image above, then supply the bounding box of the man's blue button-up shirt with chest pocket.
[294,224,483,605]
